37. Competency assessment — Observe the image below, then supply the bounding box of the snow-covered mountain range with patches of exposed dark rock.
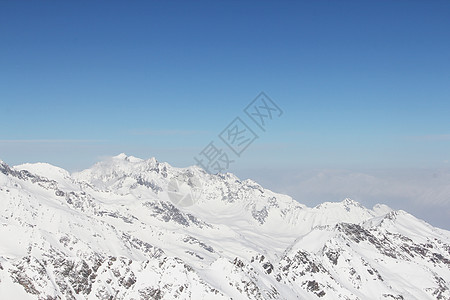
[0,154,450,299]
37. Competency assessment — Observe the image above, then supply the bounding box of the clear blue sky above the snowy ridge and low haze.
[0,1,450,228]
